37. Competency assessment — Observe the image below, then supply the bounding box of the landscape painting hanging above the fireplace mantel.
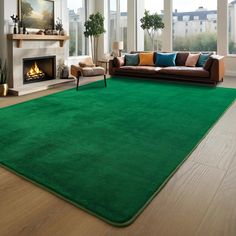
[18,0,54,29]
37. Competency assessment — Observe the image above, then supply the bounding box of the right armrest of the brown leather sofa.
[210,55,225,82]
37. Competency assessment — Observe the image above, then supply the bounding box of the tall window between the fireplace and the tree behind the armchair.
[68,0,87,56]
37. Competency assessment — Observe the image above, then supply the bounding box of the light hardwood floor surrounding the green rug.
[0,78,236,236]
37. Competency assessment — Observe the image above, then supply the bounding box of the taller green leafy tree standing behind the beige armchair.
[84,12,106,64]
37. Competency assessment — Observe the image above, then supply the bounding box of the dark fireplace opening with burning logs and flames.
[23,56,56,84]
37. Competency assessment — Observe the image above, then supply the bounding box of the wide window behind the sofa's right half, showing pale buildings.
[173,0,217,51]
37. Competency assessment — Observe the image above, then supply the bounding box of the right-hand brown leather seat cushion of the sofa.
[158,66,209,77]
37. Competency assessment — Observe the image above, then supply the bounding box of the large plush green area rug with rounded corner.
[0,78,236,226]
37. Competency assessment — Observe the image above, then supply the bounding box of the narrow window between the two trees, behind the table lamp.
[108,0,127,52]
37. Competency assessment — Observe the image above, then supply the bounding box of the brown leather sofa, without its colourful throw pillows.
[109,52,225,85]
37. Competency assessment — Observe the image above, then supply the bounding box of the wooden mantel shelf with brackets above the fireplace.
[7,34,69,48]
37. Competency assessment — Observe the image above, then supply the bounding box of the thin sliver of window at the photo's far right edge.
[228,0,236,54]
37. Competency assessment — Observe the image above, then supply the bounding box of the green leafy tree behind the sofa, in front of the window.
[140,10,165,50]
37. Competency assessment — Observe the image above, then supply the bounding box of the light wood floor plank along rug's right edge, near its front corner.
[107,162,225,236]
